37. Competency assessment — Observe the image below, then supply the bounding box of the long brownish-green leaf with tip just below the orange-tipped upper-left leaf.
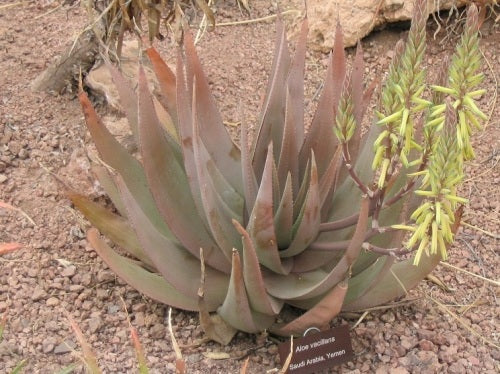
[138,69,229,272]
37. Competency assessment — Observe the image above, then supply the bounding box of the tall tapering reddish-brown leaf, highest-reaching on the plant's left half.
[184,32,243,195]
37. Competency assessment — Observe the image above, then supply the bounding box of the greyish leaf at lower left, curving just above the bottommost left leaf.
[117,179,228,311]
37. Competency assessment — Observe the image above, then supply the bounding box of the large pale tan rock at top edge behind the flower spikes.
[307,0,467,52]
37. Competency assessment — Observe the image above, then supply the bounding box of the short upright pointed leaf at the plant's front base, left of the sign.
[217,251,275,333]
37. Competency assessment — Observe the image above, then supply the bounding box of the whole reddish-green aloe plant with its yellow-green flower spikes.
[69,0,484,342]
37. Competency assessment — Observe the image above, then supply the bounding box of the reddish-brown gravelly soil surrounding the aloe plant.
[0,0,500,374]
